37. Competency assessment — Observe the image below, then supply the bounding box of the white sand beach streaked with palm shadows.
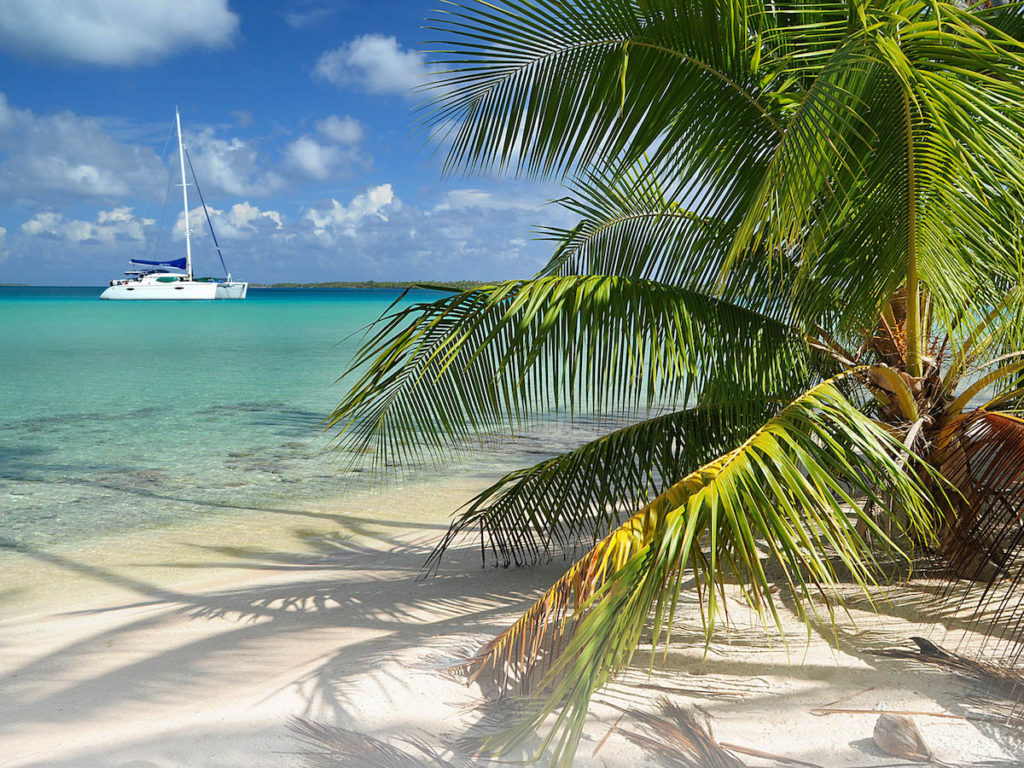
[0,481,1024,768]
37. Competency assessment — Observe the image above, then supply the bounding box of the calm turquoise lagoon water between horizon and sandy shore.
[0,288,448,548]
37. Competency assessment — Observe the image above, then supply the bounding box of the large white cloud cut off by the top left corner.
[0,0,239,67]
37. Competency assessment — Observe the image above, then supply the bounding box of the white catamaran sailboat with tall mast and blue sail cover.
[99,108,249,300]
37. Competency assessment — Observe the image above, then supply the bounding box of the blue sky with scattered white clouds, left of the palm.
[0,0,567,285]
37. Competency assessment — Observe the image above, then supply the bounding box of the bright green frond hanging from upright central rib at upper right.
[733,3,1024,331]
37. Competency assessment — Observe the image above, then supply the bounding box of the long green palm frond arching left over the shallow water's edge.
[328,275,807,464]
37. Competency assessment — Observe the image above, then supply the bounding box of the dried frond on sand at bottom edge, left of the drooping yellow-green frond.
[289,718,455,768]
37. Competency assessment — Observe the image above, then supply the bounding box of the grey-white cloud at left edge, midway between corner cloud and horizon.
[0,93,165,205]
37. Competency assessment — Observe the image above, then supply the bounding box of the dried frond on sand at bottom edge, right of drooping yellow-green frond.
[616,697,746,768]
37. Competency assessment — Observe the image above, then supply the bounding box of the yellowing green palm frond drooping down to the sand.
[469,381,934,766]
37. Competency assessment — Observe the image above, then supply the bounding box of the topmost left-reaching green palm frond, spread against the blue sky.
[424,0,778,182]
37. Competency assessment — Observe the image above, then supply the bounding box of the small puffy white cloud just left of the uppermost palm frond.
[313,34,430,96]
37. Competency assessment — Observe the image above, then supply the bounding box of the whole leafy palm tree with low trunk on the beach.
[331,0,1024,765]
